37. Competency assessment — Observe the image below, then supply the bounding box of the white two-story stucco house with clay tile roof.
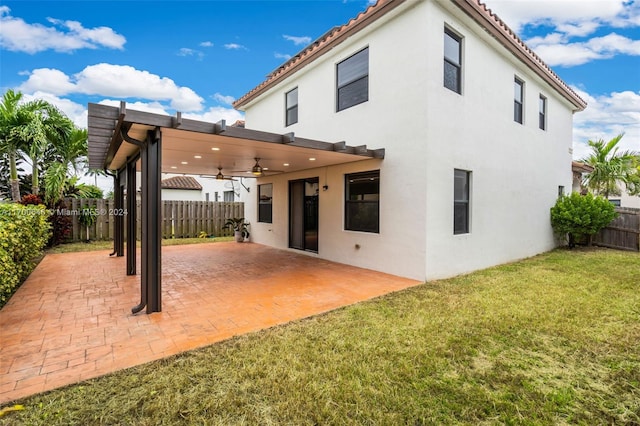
[235,0,586,280]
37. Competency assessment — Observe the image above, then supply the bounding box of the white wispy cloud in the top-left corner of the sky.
[0,6,126,54]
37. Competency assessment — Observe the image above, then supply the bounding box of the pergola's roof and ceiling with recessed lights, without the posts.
[89,102,384,177]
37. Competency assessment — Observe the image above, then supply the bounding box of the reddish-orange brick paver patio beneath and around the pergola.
[0,242,419,404]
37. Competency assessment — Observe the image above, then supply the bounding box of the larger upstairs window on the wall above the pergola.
[336,47,369,111]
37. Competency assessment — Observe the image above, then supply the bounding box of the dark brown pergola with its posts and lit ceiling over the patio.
[88,102,384,313]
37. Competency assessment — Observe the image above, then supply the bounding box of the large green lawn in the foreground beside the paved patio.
[0,249,640,425]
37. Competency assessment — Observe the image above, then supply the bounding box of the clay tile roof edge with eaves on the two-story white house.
[233,0,587,110]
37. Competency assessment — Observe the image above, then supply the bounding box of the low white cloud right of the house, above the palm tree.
[573,87,640,159]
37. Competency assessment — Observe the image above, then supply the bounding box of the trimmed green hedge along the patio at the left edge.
[0,203,49,307]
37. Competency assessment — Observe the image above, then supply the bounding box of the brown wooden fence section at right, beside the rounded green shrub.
[593,208,640,251]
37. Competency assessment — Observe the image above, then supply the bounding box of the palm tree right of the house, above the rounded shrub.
[580,133,639,198]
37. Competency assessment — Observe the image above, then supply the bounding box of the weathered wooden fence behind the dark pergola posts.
[65,199,244,241]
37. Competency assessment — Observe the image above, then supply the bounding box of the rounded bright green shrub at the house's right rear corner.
[551,192,618,248]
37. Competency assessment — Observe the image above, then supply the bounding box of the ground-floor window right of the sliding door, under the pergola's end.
[344,170,380,233]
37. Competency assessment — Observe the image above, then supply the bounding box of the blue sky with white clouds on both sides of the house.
[0,0,640,168]
